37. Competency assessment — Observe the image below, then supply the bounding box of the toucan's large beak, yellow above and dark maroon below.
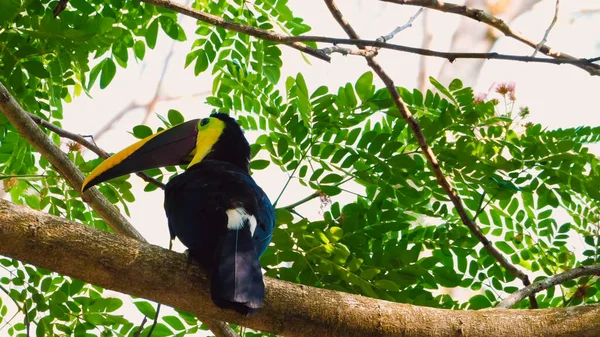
[81,119,199,191]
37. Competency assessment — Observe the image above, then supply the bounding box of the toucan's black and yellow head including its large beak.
[82,113,250,191]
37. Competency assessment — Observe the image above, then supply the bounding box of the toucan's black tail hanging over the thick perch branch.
[211,226,265,315]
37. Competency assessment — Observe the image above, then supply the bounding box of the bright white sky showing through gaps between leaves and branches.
[0,0,600,335]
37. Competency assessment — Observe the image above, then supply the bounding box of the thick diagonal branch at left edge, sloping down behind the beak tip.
[0,83,144,240]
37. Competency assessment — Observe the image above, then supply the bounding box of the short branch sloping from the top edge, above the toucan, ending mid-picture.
[139,0,331,62]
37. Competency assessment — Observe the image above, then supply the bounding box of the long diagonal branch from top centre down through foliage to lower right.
[325,0,537,308]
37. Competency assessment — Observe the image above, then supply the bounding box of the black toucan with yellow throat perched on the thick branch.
[82,113,275,315]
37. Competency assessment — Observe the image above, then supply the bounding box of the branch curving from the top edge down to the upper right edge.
[380,0,600,76]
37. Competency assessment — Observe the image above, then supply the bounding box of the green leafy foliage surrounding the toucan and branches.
[0,0,600,336]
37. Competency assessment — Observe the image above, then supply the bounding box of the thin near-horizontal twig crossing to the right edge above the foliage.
[285,35,600,66]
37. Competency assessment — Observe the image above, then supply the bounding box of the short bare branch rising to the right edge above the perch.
[497,265,600,309]
